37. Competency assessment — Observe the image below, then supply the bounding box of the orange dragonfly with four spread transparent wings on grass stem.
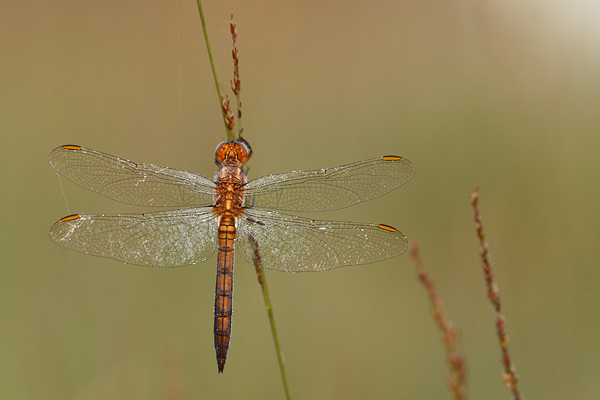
[48,138,415,373]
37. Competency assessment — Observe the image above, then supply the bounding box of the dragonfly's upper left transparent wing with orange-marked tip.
[48,145,215,207]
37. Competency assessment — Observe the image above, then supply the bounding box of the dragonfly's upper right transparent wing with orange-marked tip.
[245,156,415,211]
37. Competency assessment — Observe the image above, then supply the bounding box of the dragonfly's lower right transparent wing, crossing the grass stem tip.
[235,209,407,272]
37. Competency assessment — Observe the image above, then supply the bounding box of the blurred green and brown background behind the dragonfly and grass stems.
[0,0,600,399]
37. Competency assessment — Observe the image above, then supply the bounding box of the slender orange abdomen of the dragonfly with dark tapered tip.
[214,212,236,373]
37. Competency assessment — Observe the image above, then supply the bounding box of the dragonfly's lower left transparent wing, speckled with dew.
[50,207,217,267]
